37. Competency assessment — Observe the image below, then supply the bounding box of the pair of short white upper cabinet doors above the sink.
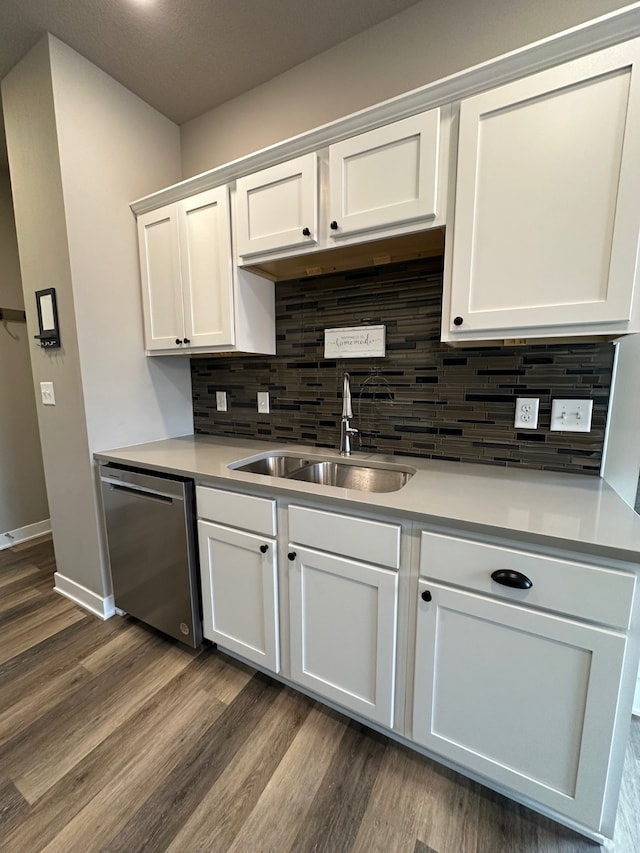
[235,107,451,264]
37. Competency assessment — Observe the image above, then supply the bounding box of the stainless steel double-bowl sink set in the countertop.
[229,453,415,492]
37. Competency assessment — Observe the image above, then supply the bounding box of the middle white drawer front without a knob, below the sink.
[289,506,400,569]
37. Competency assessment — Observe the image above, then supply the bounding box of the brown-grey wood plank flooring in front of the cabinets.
[0,540,640,853]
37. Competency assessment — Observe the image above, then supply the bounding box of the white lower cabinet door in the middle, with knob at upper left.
[289,545,398,727]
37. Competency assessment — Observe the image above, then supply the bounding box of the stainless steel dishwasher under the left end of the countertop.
[100,463,202,648]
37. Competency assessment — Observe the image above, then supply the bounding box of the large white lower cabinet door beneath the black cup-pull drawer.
[413,580,626,831]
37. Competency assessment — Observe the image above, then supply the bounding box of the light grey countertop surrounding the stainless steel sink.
[95,435,640,563]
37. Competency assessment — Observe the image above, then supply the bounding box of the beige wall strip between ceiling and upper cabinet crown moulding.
[181,0,628,178]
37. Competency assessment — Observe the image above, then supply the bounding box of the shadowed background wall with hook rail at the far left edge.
[0,168,49,548]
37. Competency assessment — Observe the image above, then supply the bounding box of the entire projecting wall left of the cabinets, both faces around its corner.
[2,36,192,599]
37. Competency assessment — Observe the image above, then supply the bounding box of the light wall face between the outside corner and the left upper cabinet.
[51,38,193,452]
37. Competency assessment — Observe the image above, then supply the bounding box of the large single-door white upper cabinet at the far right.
[442,40,640,341]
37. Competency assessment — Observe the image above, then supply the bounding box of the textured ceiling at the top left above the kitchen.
[0,0,417,159]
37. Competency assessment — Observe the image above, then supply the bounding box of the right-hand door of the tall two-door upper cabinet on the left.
[177,186,235,347]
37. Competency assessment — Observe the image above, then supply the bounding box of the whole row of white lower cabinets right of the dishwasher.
[196,486,638,837]
